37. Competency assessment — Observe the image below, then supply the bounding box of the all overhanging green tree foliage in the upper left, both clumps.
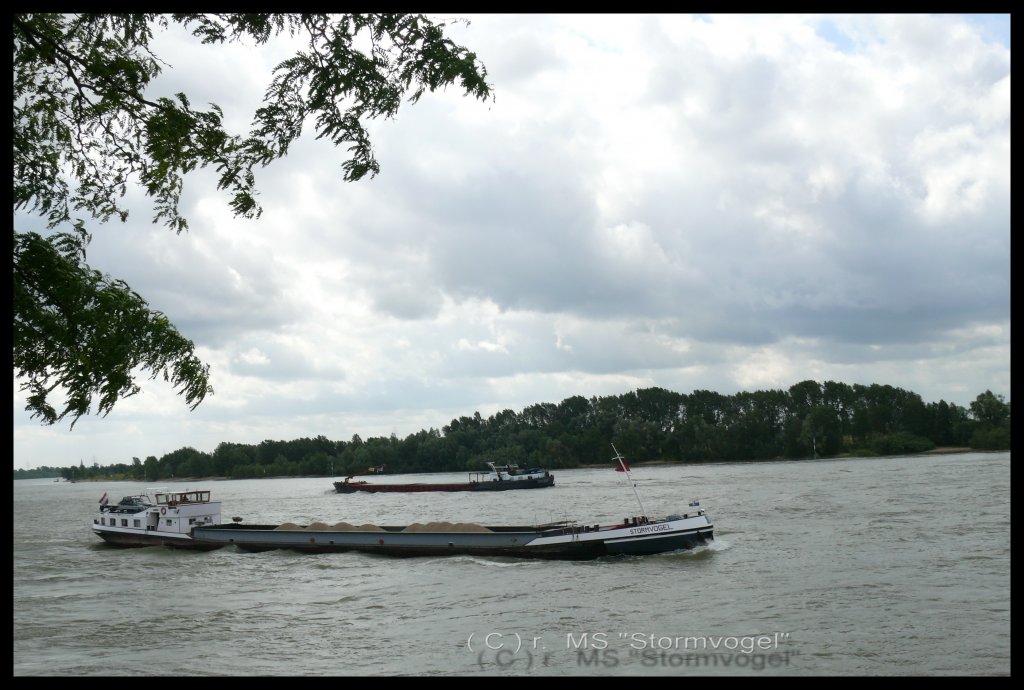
[13,13,490,426]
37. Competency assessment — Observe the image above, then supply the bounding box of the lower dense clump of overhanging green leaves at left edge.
[13,225,212,427]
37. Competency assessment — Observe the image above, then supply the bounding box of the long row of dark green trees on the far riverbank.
[14,381,1010,481]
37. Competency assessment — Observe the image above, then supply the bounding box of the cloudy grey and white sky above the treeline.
[13,14,1011,468]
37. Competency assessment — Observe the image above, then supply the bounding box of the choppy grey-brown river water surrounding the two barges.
[13,452,1010,677]
